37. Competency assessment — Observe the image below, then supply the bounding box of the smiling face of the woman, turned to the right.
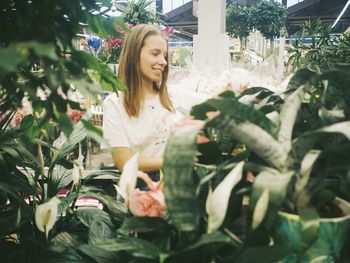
[140,35,168,82]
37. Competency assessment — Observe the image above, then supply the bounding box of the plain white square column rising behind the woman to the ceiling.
[193,0,229,70]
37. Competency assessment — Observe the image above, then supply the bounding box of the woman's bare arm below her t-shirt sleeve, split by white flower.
[112,147,163,172]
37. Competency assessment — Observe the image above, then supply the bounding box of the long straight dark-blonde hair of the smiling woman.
[118,24,174,117]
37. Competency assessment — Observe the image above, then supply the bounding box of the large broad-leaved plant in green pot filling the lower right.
[187,65,350,262]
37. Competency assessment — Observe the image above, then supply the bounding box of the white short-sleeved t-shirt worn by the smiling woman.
[103,93,179,158]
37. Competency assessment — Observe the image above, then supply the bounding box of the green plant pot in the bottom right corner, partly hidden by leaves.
[273,198,350,263]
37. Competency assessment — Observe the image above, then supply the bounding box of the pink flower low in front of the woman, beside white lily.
[129,173,166,217]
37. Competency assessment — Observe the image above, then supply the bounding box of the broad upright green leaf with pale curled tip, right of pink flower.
[164,124,203,231]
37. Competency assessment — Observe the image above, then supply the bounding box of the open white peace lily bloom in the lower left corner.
[35,197,60,238]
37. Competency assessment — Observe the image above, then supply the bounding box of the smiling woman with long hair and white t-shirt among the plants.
[103,25,177,176]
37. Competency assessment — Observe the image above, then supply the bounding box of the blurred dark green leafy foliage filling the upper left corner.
[0,0,126,136]
